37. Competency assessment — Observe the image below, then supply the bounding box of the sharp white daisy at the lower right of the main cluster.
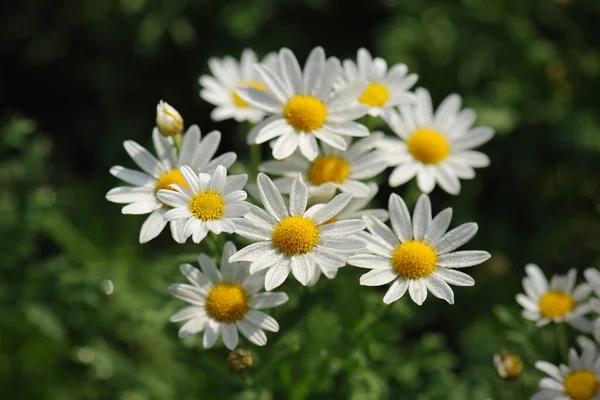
[348,193,490,305]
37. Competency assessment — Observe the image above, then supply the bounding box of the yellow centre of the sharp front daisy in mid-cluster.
[272,215,319,256]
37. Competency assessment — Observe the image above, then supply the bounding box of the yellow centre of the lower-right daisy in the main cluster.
[392,240,437,279]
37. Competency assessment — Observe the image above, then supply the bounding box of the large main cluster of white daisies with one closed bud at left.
[106,47,494,349]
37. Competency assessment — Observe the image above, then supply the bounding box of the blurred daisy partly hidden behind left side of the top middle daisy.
[199,49,276,124]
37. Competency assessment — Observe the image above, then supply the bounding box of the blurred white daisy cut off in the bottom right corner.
[531,340,600,400]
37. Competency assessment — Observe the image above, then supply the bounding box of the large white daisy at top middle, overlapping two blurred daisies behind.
[237,47,369,160]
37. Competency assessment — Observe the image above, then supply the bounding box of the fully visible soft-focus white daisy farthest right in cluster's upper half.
[381,88,494,195]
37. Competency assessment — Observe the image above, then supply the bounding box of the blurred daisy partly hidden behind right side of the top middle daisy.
[342,49,419,117]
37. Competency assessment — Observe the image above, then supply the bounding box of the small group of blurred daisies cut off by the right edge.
[512,264,600,400]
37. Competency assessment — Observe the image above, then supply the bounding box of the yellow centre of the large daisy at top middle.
[283,96,327,132]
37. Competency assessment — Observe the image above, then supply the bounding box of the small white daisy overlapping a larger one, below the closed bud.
[157,165,248,243]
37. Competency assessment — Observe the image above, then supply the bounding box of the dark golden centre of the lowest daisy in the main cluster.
[204,283,249,323]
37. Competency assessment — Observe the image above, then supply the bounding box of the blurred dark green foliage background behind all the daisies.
[0,0,600,400]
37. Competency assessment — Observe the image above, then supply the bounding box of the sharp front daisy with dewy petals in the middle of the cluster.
[229,173,365,290]
